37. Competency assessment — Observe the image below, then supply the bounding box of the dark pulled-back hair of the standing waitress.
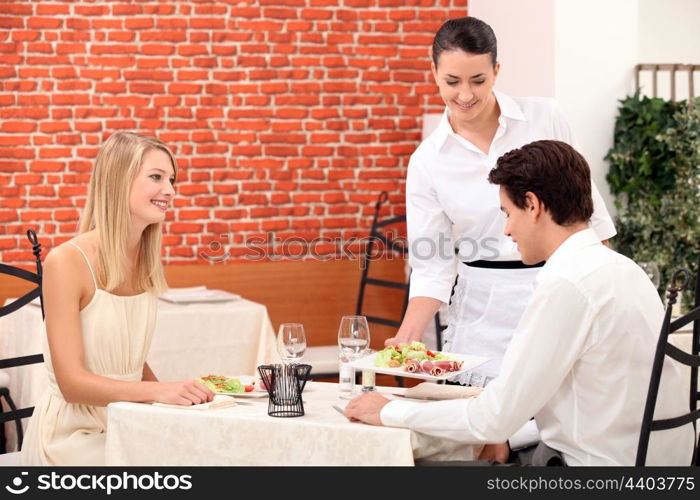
[433,17,497,68]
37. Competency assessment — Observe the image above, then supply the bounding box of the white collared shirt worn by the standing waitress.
[406,91,615,302]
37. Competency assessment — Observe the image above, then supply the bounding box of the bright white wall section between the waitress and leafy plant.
[554,0,639,210]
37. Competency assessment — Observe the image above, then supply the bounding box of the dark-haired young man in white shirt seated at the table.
[345,141,693,465]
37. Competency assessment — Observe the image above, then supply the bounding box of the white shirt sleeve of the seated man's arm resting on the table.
[380,280,595,443]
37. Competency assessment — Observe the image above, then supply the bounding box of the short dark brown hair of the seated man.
[489,141,593,226]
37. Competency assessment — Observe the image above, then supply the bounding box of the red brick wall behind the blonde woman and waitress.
[0,0,467,263]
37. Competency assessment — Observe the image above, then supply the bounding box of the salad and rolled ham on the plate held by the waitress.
[374,342,462,377]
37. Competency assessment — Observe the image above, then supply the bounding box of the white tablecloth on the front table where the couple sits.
[106,382,481,466]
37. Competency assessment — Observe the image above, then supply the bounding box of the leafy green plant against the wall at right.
[606,93,700,307]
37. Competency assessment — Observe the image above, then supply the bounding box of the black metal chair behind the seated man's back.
[635,269,700,466]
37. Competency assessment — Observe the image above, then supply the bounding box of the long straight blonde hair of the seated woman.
[79,132,177,293]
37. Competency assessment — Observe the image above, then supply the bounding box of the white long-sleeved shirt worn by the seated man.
[381,229,693,465]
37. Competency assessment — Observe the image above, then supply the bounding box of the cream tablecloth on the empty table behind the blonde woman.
[0,299,279,450]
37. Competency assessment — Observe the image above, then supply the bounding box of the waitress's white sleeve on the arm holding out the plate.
[406,154,457,303]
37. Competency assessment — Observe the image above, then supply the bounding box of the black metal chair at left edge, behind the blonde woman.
[0,229,44,453]
